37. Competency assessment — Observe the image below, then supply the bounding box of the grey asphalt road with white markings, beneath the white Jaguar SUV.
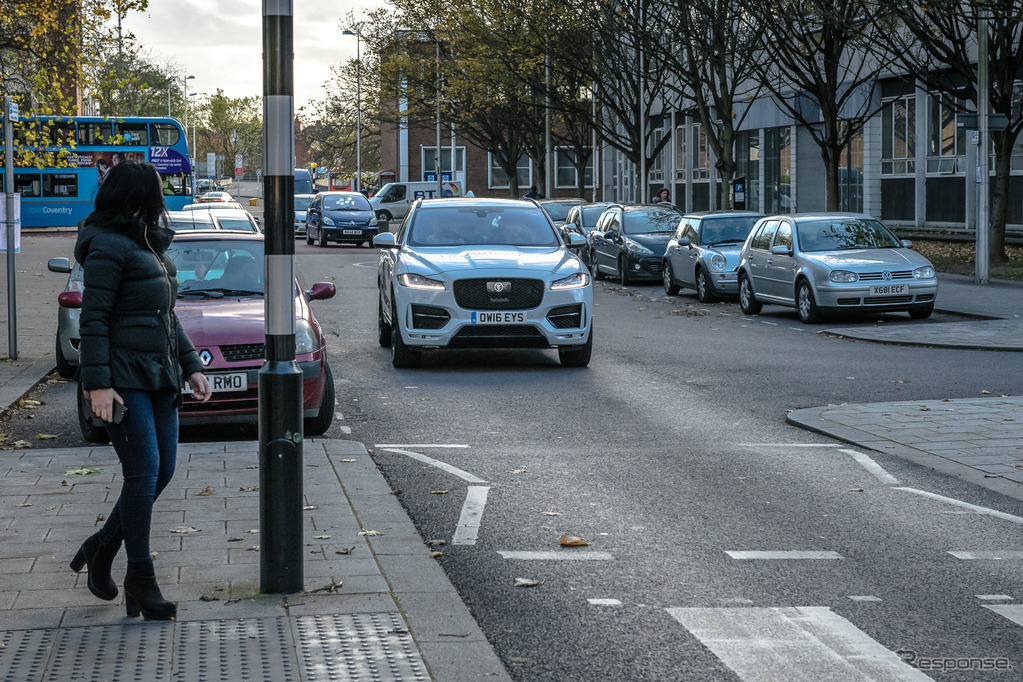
[5,242,1023,681]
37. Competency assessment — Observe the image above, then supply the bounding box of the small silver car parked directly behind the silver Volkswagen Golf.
[662,211,763,303]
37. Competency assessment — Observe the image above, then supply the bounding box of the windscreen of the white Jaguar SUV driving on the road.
[408,206,562,246]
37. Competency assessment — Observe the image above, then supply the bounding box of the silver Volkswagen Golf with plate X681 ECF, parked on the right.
[739,214,938,324]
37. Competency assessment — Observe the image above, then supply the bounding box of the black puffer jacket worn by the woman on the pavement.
[75,213,203,391]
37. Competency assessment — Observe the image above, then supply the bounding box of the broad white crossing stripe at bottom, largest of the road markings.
[666,606,931,682]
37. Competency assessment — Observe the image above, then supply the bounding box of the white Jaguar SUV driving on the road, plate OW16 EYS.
[373,198,593,367]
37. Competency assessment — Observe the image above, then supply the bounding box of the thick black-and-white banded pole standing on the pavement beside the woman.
[259,0,304,594]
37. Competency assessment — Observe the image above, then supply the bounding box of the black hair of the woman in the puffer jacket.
[96,161,166,229]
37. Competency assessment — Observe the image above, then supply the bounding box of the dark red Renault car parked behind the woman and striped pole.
[51,230,336,443]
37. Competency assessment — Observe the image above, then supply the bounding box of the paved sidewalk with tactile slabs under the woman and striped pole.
[0,440,508,682]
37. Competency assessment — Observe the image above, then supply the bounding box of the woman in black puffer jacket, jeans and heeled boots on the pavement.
[71,161,210,621]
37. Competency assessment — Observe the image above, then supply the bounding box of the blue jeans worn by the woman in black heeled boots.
[99,389,178,561]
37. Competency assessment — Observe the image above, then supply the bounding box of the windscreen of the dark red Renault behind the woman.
[167,239,264,299]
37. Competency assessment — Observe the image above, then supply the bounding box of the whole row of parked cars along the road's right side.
[539,199,938,323]
